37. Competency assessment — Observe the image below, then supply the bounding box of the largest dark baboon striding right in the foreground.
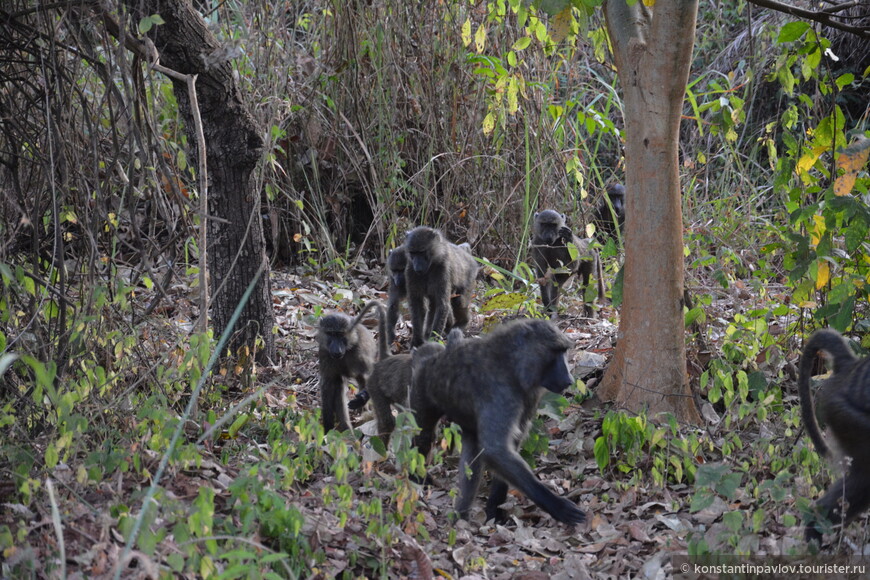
[411,319,586,524]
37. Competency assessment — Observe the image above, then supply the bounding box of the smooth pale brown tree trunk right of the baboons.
[598,0,700,423]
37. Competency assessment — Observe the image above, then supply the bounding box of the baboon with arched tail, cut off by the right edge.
[798,330,870,544]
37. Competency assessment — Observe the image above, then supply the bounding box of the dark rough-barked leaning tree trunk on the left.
[126,0,275,359]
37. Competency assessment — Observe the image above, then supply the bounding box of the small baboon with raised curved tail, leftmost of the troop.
[317,300,384,431]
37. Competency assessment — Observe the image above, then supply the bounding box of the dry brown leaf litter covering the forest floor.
[6,264,868,580]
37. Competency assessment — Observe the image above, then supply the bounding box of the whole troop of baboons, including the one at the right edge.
[317,184,870,544]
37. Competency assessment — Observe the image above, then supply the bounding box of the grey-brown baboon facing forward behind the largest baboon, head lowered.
[405,226,477,346]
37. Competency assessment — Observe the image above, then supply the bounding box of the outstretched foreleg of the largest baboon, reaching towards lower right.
[483,439,586,524]
